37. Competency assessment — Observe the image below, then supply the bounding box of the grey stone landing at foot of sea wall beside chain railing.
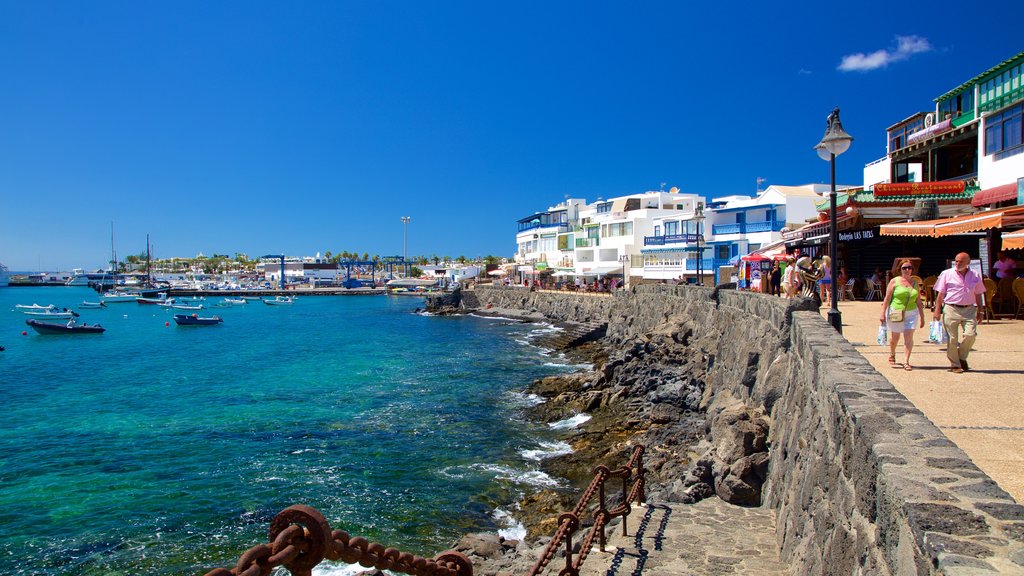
[580,497,790,576]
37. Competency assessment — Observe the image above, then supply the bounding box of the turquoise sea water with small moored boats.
[0,287,579,575]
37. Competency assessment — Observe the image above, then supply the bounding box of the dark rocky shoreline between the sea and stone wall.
[368,305,767,576]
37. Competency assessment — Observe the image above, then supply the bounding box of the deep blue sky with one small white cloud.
[0,0,1024,270]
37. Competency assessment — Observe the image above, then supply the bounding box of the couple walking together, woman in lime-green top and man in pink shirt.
[879,252,985,374]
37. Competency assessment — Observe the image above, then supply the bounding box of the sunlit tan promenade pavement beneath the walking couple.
[821,301,1024,503]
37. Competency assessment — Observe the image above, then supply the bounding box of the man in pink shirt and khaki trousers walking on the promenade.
[935,252,985,374]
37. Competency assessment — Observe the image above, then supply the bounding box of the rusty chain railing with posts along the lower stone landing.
[528,446,646,576]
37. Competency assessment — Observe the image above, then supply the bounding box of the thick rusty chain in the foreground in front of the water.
[206,504,473,576]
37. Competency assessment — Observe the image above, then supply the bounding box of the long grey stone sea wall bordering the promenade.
[463,286,1024,575]
